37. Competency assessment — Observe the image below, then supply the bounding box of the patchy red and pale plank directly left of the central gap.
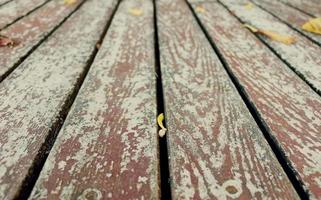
[31,0,160,199]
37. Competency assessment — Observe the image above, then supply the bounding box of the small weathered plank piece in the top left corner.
[0,0,48,30]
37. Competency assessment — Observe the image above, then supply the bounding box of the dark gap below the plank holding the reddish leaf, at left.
[0,0,87,83]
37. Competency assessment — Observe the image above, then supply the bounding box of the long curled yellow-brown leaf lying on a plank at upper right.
[244,24,295,45]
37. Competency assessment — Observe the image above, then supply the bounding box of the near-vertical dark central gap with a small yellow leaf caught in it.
[153,0,172,200]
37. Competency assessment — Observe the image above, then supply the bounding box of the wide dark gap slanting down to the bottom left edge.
[14,0,122,200]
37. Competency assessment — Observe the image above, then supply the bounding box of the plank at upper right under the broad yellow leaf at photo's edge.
[252,0,321,45]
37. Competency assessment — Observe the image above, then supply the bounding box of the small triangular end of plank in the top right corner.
[280,0,321,17]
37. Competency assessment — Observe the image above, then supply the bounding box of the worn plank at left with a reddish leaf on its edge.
[0,0,82,81]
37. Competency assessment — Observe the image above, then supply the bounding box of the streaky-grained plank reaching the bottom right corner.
[189,2,321,199]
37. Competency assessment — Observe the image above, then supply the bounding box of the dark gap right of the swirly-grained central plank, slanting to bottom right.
[185,0,309,199]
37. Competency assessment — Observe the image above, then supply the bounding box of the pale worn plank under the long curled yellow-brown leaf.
[221,0,321,94]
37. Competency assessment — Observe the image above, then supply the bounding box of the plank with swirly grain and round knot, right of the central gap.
[156,0,298,199]
